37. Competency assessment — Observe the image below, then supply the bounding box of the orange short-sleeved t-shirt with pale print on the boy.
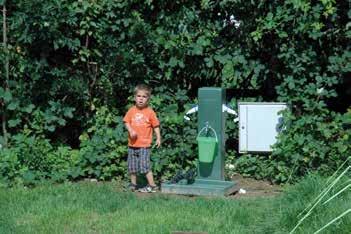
[123,106,160,147]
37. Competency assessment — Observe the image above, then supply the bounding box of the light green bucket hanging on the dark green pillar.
[196,126,218,163]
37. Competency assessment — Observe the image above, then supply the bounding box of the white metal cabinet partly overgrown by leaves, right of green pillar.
[238,102,287,153]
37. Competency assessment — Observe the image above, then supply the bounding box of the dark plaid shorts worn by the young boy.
[128,147,150,174]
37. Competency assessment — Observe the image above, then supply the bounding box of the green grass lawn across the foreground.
[0,176,351,234]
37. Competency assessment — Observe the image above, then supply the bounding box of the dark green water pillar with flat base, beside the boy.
[161,87,237,196]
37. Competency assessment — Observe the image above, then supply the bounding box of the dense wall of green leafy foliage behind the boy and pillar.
[0,0,351,184]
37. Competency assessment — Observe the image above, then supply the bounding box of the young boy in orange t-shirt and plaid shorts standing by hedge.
[123,84,161,193]
